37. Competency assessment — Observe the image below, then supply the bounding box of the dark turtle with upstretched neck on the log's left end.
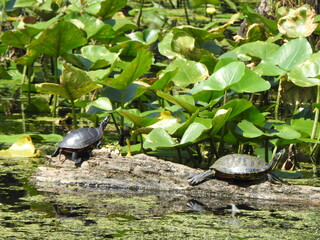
[51,115,110,166]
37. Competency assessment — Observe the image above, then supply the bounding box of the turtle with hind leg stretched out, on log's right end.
[188,149,285,186]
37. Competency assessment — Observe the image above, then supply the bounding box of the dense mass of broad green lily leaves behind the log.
[0,0,320,171]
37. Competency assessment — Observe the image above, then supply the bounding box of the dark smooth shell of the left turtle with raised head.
[58,128,103,149]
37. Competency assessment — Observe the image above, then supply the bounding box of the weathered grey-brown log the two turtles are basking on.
[32,149,320,205]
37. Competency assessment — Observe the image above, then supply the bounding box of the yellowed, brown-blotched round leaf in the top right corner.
[278,5,318,38]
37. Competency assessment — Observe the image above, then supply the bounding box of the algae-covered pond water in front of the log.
[0,159,320,240]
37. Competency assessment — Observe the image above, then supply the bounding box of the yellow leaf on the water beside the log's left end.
[0,136,40,157]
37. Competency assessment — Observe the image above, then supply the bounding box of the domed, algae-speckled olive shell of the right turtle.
[210,154,271,179]
